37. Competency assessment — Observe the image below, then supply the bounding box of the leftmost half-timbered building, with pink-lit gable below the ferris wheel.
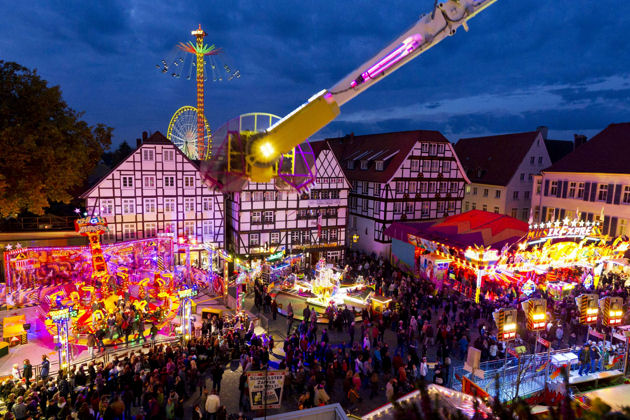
[81,132,224,263]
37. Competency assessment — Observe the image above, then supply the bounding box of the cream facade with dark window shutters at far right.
[532,172,630,237]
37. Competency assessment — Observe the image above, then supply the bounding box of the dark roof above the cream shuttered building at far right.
[543,122,630,174]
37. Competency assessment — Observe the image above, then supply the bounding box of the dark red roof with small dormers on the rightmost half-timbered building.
[327,130,448,183]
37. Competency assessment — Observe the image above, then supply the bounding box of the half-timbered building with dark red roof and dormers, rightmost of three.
[328,130,468,256]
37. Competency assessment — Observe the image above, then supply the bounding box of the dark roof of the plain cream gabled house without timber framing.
[455,131,540,186]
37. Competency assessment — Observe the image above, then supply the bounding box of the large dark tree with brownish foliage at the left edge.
[0,60,113,217]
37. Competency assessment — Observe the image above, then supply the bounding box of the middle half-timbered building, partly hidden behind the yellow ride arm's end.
[226,141,350,262]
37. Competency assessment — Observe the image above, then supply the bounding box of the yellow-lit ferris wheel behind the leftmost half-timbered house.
[166,105,212,160]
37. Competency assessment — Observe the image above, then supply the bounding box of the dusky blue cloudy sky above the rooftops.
[0,0,630,145]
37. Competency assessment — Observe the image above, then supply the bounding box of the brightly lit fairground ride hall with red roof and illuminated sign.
[385,210,628,301]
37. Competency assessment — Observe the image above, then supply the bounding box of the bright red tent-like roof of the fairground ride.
[385,210,529,250]
